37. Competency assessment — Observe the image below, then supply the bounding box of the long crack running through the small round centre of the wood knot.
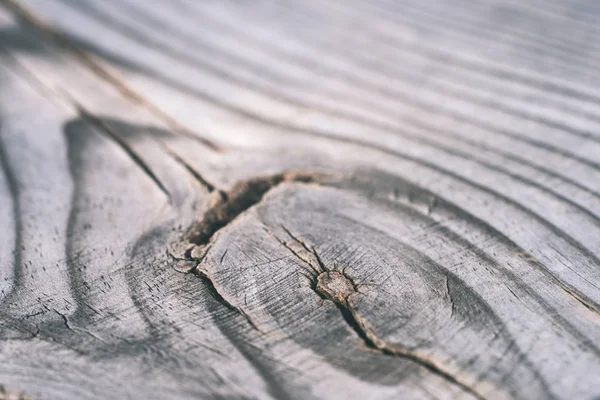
[272,227,484,399]
